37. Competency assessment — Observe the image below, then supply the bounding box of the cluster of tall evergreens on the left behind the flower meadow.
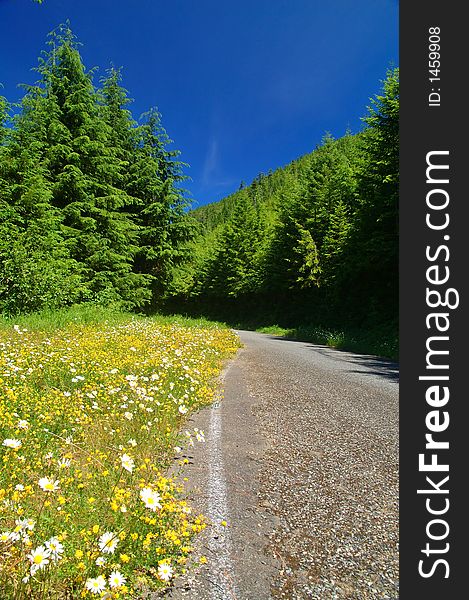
[0,24,193,314]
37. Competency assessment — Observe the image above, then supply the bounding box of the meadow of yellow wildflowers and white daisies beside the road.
[0,317,239,600]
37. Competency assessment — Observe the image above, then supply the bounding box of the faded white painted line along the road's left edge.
[207,372,237,600]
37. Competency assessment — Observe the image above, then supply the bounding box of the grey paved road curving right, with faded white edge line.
[163,331,399,600]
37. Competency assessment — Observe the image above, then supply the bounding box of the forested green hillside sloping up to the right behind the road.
[173,69,399,354]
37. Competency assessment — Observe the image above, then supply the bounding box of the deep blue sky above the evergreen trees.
[0,0,399,205]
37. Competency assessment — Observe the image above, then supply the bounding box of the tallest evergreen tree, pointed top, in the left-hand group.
[31,25,149,307]
